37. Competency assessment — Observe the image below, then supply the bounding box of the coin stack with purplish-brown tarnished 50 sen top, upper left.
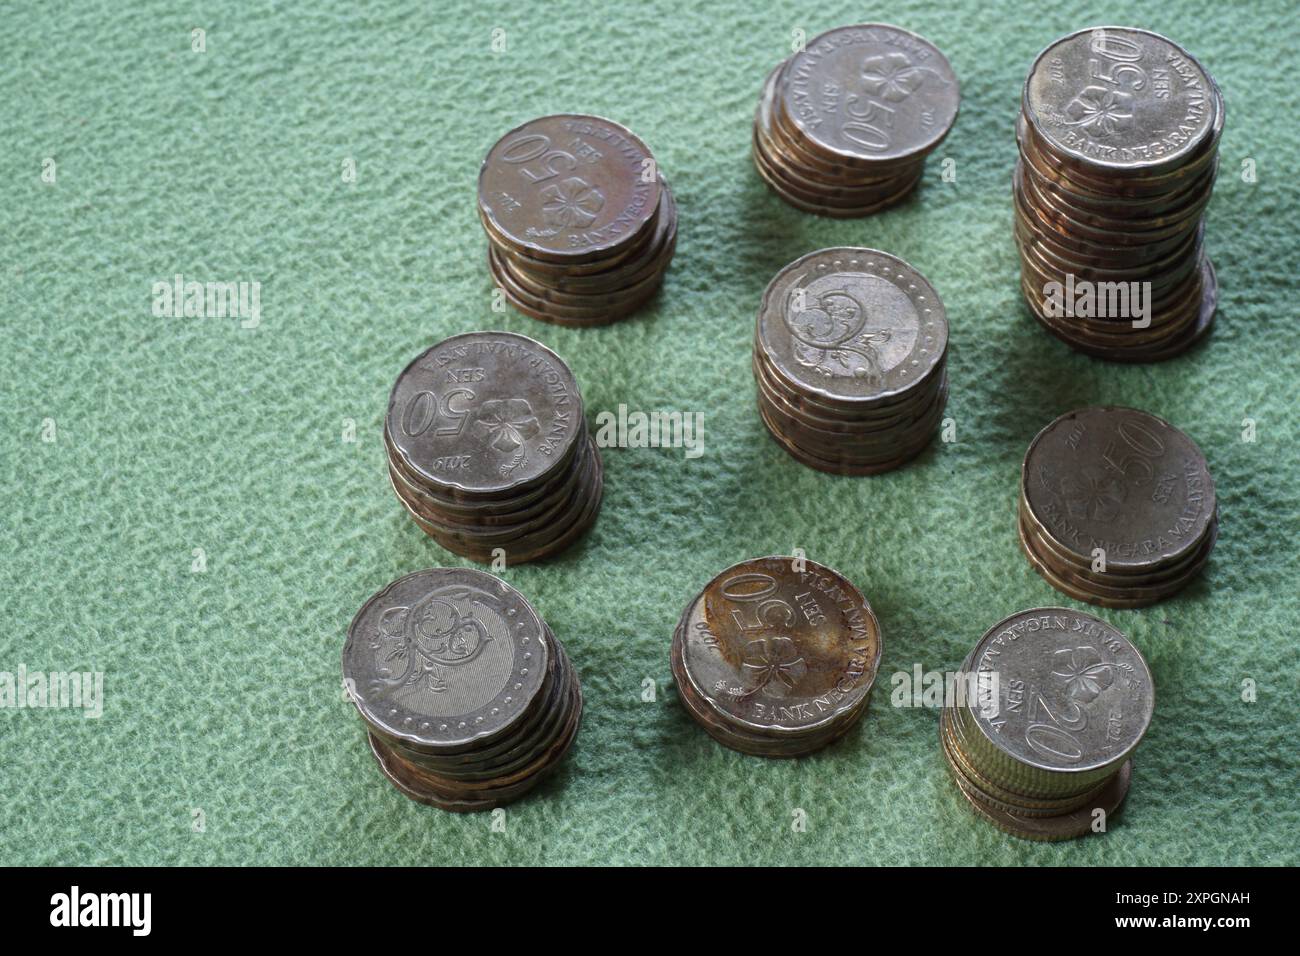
[478,113,677,325]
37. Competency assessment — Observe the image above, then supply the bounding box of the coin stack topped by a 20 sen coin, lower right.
[939,607,1156,840]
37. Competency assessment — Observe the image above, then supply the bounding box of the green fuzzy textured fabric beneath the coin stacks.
[0,0,1300,864]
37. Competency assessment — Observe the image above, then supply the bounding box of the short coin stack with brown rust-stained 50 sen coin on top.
[670,557,881,757]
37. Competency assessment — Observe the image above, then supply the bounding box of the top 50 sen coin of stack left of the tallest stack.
[777,23,961,163]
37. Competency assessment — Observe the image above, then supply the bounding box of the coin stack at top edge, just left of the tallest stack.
[753,23,961,219]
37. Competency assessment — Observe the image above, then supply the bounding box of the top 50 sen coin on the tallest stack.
[1023,26,1217,174]
